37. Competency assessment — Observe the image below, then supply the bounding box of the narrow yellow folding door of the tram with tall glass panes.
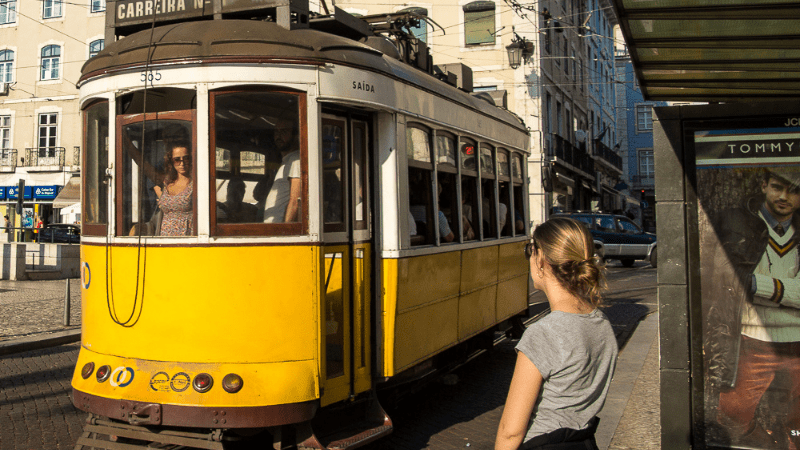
[321,115,372,406]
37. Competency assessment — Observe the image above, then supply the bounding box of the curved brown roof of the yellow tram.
[84,20,527,135]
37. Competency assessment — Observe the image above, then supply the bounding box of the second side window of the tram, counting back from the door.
[436,132,458,243]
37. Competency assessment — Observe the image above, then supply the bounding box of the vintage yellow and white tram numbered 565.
[72,0,528,448]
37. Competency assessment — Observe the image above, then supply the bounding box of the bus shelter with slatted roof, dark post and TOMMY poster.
[613,0,800,450]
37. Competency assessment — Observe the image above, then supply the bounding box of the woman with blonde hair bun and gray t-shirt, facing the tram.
[495,218,618,450]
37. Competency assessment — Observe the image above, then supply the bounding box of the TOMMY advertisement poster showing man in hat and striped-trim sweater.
[691,126,800,450]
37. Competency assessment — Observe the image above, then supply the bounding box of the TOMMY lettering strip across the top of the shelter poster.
[694,129,800,166]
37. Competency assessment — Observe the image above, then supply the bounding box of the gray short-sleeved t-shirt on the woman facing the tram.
[517,309,619,441]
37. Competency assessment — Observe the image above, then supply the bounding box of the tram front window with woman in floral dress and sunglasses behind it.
[117,119,196,236]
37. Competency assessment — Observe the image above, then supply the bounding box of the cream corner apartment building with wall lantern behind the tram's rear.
[336,0,623,223]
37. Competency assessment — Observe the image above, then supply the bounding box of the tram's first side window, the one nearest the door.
[406,123,438,247]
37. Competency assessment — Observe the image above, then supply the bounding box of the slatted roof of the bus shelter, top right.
[612,0,800,102]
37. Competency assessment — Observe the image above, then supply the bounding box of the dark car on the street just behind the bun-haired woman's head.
[553,212,658,267]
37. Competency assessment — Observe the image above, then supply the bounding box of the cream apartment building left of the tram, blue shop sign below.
[0,0,106,230]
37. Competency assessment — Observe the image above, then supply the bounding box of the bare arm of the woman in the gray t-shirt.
[494,352,543,450]
